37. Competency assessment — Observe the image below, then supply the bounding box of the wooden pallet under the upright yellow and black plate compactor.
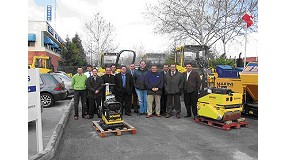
[92,121,137,138]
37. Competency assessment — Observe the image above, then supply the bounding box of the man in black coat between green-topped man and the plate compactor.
[86,69,104,119]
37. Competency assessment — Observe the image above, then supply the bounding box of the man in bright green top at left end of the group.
[71,68,87,120]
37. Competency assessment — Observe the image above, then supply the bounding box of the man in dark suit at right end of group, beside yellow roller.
[182,63,201,119]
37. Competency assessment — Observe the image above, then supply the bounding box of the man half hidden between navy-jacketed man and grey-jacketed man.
[160,64,169,116]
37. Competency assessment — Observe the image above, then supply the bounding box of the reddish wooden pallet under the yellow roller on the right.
[195,117,248,131]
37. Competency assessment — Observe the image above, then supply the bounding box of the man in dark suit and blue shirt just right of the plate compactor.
[115,66,133,116]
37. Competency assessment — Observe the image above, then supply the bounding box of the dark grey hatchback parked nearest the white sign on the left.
[40,73,67,107]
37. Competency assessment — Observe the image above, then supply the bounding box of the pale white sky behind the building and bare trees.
[29,0,258,57]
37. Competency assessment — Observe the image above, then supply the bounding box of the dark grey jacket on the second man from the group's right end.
[164,70,183,95]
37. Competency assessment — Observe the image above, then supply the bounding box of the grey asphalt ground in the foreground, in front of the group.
[53,102,258,160]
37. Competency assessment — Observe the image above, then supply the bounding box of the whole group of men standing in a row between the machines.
[72,61,201,120]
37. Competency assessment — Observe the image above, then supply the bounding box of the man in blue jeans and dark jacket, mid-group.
[134,61,147,115]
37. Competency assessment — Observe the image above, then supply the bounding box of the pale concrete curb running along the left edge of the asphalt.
[29,98,74,160]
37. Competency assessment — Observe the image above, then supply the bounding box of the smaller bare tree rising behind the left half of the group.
[85,13,118,66]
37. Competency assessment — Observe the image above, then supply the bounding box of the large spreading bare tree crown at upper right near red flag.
[146,0,257,53]
